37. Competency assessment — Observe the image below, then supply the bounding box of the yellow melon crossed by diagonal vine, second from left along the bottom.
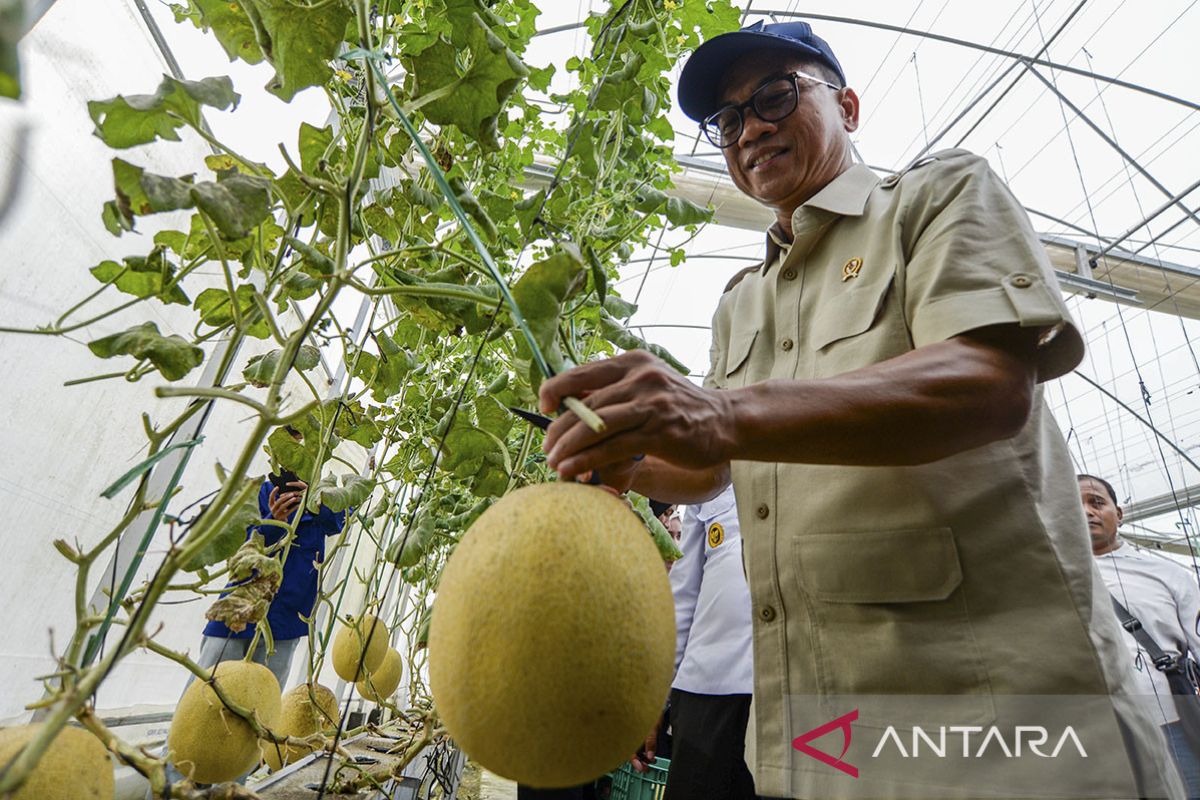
[167,661,281,783]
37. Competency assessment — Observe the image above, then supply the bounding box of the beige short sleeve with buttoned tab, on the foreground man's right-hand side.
[900,151,1084,381]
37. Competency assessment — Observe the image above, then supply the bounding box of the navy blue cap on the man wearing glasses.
[679,20,846,122]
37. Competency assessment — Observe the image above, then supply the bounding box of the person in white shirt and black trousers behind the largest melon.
[634,487,756,800]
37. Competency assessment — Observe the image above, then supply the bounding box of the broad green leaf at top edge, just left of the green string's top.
[248,0,354,101]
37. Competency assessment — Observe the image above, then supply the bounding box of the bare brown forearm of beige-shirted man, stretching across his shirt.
[727,337,1034,467]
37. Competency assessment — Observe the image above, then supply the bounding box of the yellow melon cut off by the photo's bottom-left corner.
[0,724,114,800]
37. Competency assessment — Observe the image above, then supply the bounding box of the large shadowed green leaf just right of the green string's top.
[412,0,529,148]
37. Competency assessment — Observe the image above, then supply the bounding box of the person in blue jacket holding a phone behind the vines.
[196,480,347,688]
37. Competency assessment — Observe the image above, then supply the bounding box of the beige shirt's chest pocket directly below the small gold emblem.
[808,272,911,378]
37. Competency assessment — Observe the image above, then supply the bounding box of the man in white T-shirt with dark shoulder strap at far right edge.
[1078,475,1200,798]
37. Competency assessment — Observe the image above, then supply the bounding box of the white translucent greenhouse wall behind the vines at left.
[0,0,379,724]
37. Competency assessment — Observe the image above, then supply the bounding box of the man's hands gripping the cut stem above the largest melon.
[539,350,731,491]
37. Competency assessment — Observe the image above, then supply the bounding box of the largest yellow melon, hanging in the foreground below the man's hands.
[430,483,676,788]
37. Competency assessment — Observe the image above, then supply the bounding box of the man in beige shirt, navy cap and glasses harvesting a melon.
[541,23,1178,798]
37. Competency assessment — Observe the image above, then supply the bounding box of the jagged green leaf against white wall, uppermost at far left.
[88,76,240,149]
